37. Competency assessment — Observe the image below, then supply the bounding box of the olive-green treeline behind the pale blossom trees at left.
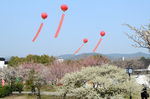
[8,54,56,66]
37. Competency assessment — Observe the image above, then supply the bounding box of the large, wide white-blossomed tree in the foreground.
[60,64,141,99]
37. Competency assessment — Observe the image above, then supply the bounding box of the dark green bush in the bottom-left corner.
[0,86,11,98]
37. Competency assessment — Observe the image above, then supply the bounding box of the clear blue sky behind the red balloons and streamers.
[0,0,150,56]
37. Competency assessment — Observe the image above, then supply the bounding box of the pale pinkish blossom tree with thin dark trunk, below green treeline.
[17,63,49,99]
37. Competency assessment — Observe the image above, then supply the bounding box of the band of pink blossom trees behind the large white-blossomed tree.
[48,55,110,84]
